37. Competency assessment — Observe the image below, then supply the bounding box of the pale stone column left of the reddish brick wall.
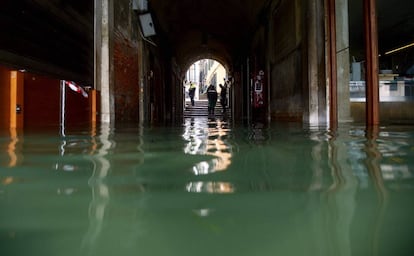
[95,0,115,123]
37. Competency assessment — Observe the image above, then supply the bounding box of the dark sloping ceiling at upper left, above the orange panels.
[0,0,94,81]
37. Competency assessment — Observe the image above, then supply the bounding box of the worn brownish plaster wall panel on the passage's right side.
[268,0,304,121]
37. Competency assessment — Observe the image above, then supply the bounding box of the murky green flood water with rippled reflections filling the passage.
[0,117,414,256]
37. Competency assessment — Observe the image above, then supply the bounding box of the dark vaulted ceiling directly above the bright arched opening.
[149,0,271,70]
